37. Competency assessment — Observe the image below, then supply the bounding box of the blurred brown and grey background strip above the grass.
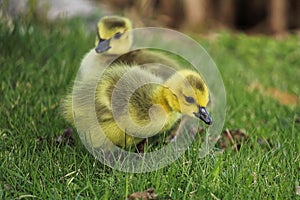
[0,0,300,34]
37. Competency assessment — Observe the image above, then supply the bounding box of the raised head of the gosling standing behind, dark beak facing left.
[95,16,132,54]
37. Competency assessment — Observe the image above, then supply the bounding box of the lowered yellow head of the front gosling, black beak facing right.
[165,70,212,125]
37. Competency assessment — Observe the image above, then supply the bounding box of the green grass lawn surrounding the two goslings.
[0,13,300,199]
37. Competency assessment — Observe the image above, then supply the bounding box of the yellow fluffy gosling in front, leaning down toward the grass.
[90,64,212,148]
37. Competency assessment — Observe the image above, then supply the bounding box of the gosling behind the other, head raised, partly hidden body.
[79,16,178,80]
